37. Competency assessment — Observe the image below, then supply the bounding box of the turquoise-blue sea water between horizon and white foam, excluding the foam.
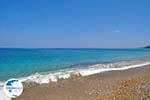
[0,48,150,81]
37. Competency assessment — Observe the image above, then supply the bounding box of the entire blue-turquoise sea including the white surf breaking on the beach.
[0,48,150,100]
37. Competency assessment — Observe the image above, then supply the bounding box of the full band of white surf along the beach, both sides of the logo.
[0,60,150,86]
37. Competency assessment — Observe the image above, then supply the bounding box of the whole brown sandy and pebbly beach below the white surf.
[13,66,150,100]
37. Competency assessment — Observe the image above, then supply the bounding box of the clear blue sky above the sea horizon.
[0,0,150,48]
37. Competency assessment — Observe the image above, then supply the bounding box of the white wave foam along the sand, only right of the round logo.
[21,62,150,84]
